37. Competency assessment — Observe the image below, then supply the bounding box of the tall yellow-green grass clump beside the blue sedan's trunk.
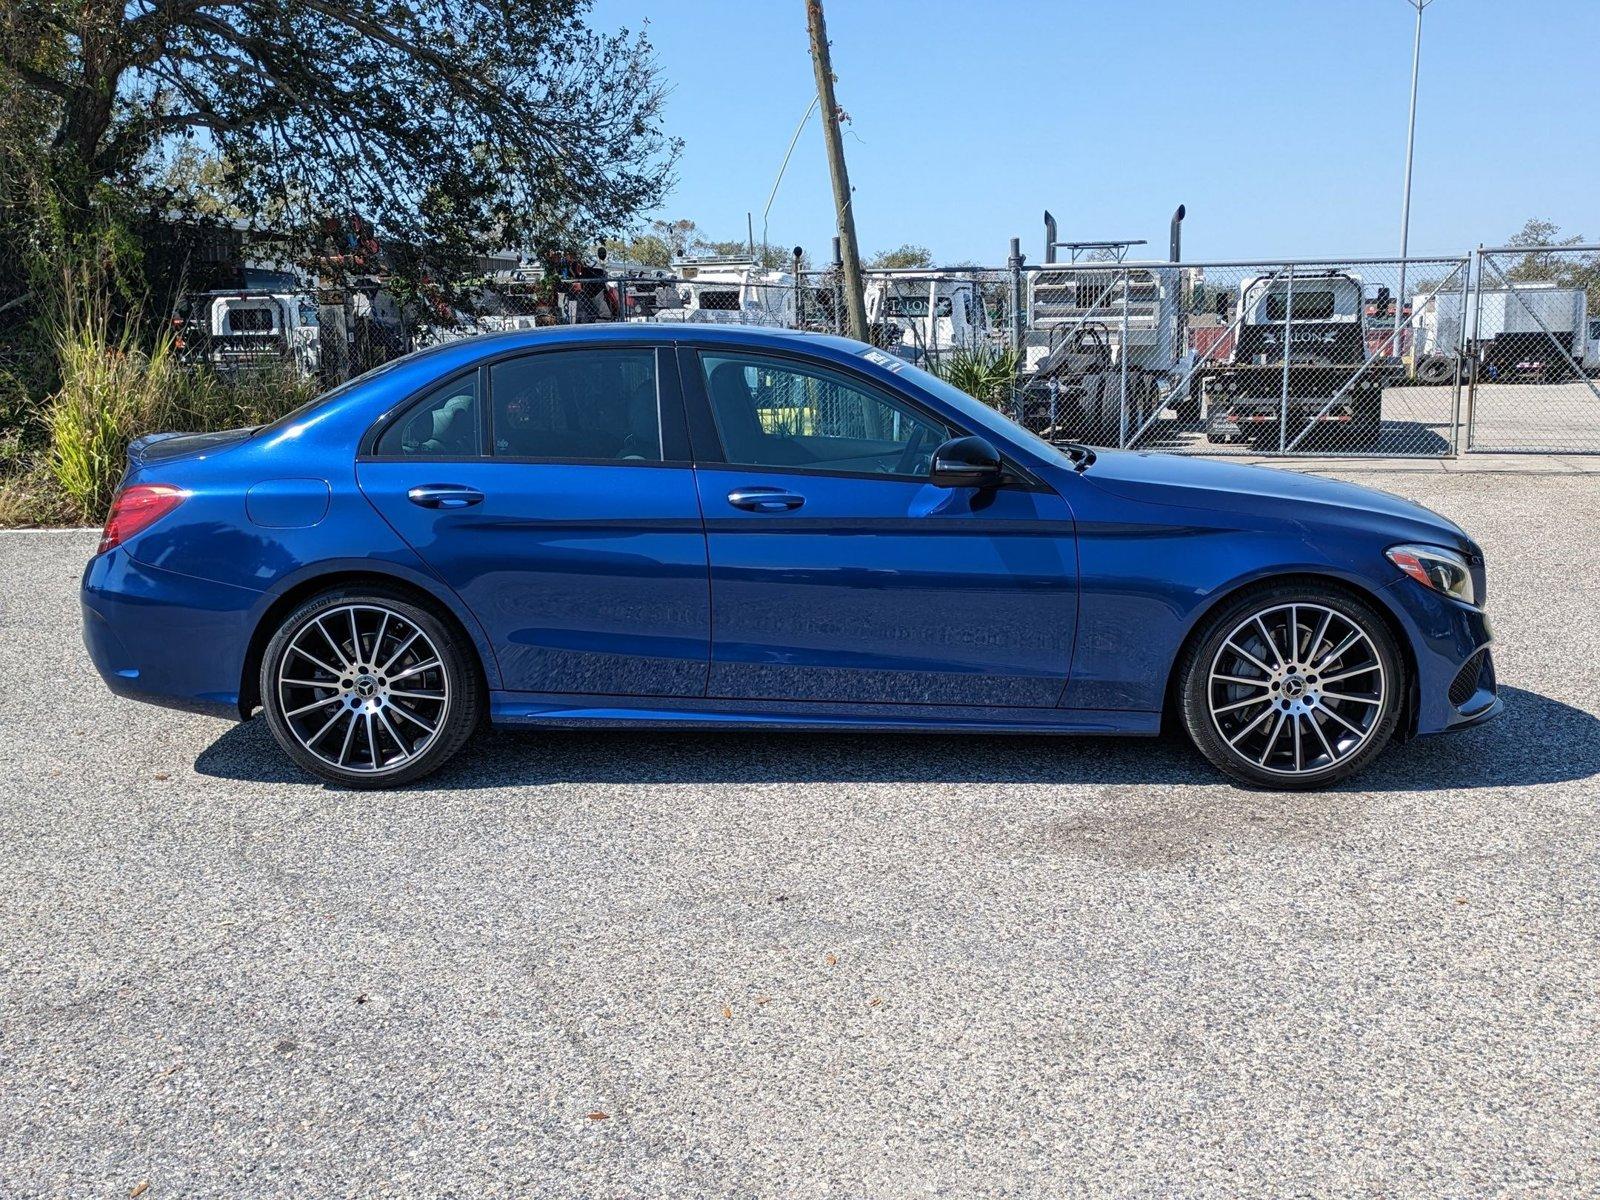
[36,270,317,522]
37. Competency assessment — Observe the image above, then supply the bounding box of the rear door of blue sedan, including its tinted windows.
[357,346,710,696]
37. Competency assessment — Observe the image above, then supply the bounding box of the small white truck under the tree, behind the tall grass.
[173,290,322,376]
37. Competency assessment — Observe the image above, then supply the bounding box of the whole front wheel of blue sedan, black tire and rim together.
[1178,582,1410,790]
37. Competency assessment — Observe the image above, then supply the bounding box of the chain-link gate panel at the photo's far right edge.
[1465,246,1600,453]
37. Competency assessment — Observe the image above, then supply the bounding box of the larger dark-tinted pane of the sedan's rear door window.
[490,347,661,462]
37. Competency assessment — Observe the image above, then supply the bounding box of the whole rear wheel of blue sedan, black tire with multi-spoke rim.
[259,586,485,789]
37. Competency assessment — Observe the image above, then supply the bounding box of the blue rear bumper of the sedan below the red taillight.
[80,549,261,720]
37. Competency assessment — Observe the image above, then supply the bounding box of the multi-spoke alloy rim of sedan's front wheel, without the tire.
[1206,603,1389,776]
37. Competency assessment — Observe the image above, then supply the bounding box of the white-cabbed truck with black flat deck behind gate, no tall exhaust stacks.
[1197,269,1405,450]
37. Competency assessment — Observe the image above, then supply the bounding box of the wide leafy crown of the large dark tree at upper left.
[0,0,678,289]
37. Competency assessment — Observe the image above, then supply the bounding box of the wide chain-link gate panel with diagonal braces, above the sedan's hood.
[1011,258,1469,456]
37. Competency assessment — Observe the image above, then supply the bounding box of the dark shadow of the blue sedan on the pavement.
[195,688,1600,792]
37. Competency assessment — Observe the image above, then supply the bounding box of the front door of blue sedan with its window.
[683,349,1077,707]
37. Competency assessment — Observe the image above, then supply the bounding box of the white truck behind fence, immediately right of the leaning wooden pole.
[862,269,992,363]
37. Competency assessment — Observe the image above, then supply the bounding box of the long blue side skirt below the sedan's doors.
[490,691,1162,738]
